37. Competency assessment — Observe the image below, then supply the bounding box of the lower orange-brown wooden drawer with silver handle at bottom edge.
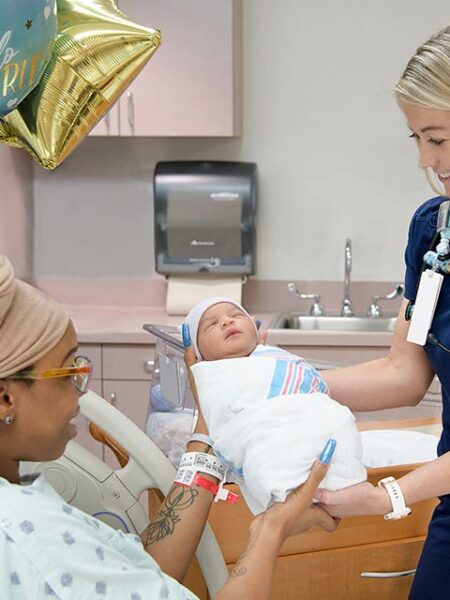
[264,538,423,600]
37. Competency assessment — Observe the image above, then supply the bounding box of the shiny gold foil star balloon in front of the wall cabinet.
[0,0,161,169]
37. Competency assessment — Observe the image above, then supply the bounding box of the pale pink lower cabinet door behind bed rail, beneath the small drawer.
[103,380,150,467]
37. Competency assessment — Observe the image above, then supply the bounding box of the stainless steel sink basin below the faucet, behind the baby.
[269,312,396,332]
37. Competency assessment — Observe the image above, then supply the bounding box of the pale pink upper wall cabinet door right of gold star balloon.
[120,0,242,136]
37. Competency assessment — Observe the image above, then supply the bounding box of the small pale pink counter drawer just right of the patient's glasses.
[103,344,155,380]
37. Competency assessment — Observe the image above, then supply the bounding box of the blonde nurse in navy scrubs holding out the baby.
[316,27,450,600]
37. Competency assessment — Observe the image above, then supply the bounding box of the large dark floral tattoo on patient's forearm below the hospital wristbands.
[143,485,198,546]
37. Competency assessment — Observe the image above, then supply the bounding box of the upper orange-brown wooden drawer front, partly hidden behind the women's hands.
[209,465,437,563]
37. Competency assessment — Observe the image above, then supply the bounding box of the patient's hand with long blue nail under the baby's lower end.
[255,448,339,541]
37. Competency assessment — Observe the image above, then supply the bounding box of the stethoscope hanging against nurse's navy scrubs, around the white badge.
[405,200,450,353]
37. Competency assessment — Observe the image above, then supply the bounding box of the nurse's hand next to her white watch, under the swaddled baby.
[314,481,392,517]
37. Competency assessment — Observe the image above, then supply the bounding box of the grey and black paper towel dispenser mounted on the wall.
[153,161,257,275]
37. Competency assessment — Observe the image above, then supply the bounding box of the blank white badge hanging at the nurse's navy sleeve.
[406,269,444,346]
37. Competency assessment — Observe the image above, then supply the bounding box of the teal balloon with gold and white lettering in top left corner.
[0,0,58,117]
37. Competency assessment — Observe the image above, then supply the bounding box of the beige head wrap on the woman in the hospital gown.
[0,255,69,379]
